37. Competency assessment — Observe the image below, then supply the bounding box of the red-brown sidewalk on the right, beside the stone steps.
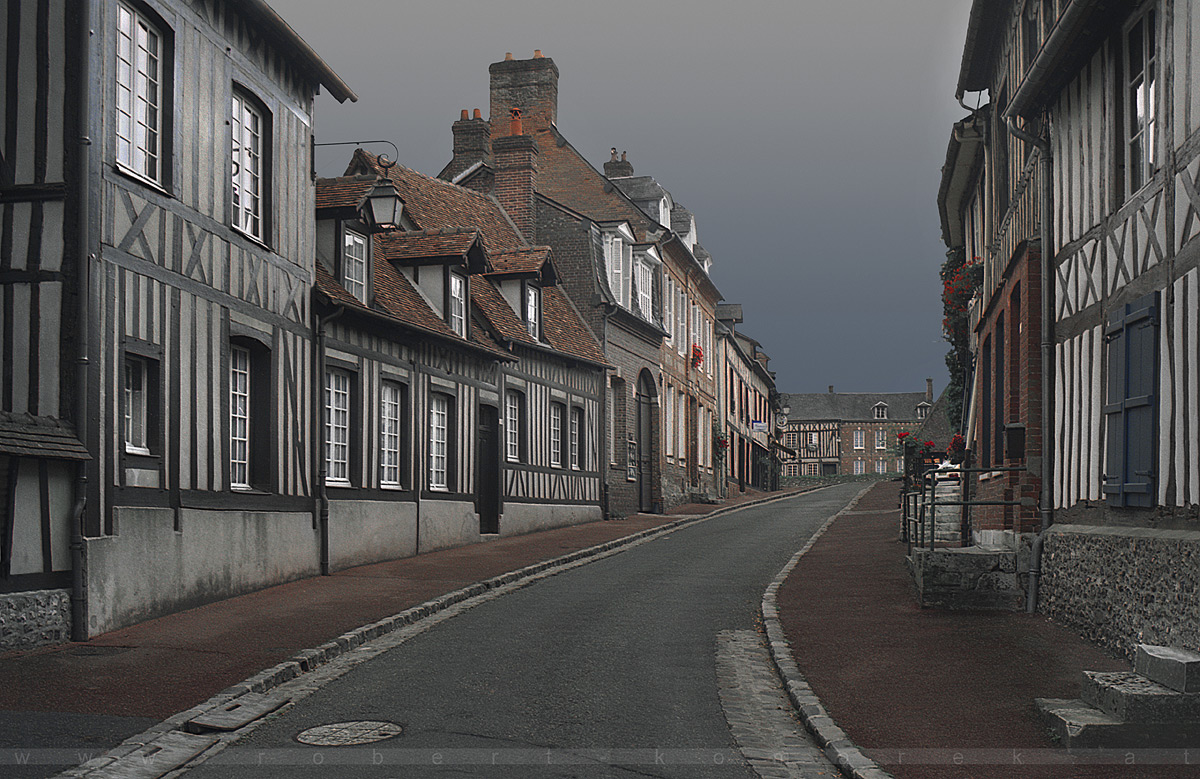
[778,483,1200,779]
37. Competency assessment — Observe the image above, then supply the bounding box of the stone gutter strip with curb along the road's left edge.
[56,487,825,779]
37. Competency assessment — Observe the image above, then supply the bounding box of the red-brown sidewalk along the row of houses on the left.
[0,489,794,719]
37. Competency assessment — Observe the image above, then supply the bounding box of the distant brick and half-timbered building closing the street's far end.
[779,379,934,477]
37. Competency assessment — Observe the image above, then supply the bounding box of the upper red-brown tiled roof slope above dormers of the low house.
[350,149,526,254]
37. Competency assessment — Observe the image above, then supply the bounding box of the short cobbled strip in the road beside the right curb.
[716,630,839,779]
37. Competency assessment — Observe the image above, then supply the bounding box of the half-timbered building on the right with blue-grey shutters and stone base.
[945,0,1200,652]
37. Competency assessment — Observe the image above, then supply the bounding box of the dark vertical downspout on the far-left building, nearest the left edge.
[70,0,96,641]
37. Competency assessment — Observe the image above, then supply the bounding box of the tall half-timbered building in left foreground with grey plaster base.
[0,0,354,637]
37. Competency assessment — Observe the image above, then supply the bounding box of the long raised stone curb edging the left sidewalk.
[55,485,820,779]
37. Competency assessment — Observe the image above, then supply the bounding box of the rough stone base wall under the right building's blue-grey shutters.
[1038,525,1200,658]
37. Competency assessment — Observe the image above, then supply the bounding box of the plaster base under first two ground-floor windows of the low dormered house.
[329,501,416,570]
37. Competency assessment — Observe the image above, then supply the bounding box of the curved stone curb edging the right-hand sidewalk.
[762,484,893,779]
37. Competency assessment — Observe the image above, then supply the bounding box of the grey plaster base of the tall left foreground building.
[86,508,320,636]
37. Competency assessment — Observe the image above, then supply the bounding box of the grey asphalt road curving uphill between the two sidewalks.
[188,484,862,779]
